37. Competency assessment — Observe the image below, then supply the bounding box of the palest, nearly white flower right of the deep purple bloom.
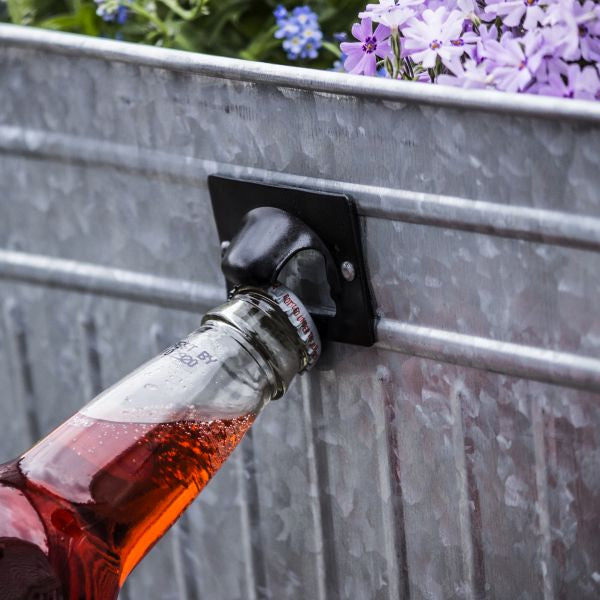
[402,7,465,69]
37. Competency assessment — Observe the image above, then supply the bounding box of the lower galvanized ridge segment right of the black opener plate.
[377,319,600,392]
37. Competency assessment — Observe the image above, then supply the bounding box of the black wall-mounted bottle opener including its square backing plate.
[208,175,375,346]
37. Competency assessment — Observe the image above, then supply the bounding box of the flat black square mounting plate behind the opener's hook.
[208,175,375,346]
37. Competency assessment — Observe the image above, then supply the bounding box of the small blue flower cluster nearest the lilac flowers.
[273,5,323,60]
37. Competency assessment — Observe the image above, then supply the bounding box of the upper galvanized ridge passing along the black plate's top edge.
[0,125,600,251]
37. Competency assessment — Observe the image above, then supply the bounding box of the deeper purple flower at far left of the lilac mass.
[340,18,392,75]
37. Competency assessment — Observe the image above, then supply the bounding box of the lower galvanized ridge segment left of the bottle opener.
[0,250,225,312]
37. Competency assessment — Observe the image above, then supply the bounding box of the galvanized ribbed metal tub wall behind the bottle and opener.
[0,26,600,600]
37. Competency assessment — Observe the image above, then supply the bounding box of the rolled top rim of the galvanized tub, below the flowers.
[0,24,600,123]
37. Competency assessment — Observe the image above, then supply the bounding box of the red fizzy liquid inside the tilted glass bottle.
[0,414,254,600]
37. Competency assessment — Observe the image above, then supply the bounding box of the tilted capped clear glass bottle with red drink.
[0,285,320,600]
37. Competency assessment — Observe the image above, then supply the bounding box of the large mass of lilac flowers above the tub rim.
[341,0,600,99]
